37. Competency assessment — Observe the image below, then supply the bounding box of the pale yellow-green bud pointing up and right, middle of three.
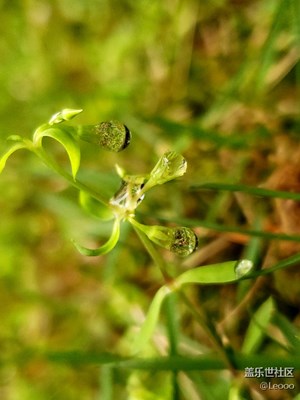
[146,151,187,190]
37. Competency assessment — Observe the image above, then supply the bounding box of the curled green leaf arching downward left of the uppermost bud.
[33,125,80,180]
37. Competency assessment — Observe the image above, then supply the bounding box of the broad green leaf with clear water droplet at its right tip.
[174,260,253,287]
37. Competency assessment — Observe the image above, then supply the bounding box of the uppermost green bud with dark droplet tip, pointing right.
[77,121,131,152]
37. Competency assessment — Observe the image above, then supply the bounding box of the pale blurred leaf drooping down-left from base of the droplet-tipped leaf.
[132,286,171,354]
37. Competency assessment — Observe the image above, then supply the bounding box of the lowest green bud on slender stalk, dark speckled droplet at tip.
[130,219,198,257]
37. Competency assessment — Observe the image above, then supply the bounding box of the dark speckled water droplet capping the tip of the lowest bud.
[170,227,198,257]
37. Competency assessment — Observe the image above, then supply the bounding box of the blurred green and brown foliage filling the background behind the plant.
[0,0,300,400]
